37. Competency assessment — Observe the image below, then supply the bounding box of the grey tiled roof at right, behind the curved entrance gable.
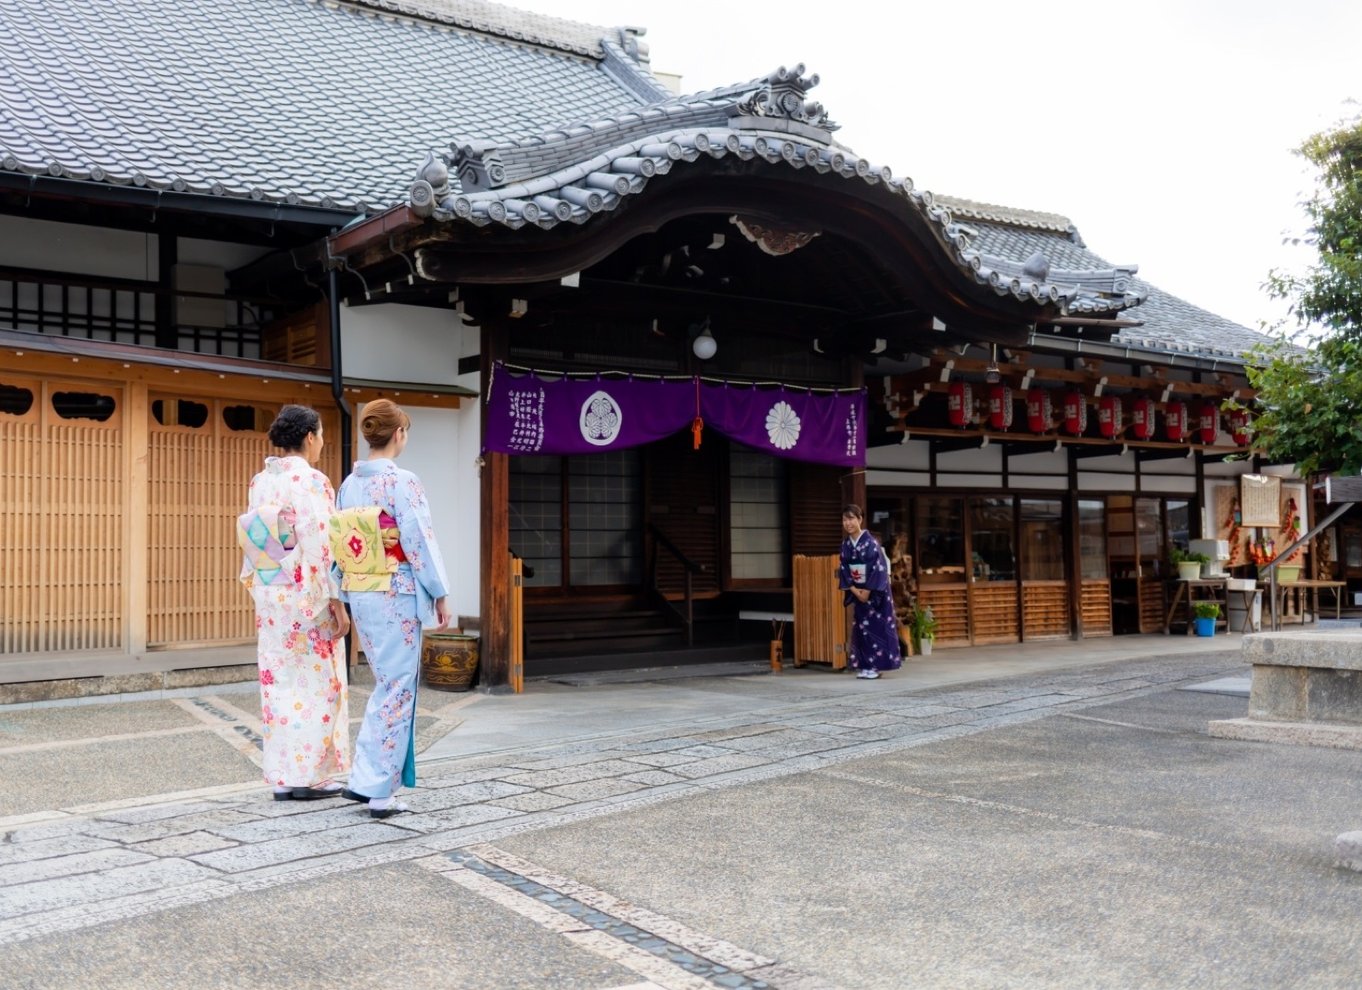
[968,222,1268,358]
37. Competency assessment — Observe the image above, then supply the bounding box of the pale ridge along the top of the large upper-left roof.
[336,0,623,59]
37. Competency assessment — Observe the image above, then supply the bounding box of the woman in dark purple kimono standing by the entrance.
[838,505,903,681]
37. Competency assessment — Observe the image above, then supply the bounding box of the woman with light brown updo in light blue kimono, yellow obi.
[331,399,449,818]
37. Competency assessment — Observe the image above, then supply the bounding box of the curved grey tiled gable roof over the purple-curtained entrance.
[410,65,1143,313]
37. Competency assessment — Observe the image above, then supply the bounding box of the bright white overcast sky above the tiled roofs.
[507,0,1362,330]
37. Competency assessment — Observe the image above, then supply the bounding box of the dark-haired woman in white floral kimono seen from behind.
[237,406,350,801]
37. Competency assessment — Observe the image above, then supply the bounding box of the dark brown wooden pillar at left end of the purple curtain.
[479,324,515,694]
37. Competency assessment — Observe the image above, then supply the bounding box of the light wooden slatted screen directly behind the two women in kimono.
[147,395,339,648]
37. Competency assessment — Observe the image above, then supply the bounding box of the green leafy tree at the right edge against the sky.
[1248,105,1362,477]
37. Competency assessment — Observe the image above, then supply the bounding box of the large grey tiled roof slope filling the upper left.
[0,0,663,212]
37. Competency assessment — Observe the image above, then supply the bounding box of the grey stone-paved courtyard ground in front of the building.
[0,637,1362,990]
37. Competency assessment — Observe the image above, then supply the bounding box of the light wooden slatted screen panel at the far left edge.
[0,377,127,654]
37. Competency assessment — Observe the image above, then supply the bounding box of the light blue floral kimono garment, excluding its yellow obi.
[336,459,449,798]
